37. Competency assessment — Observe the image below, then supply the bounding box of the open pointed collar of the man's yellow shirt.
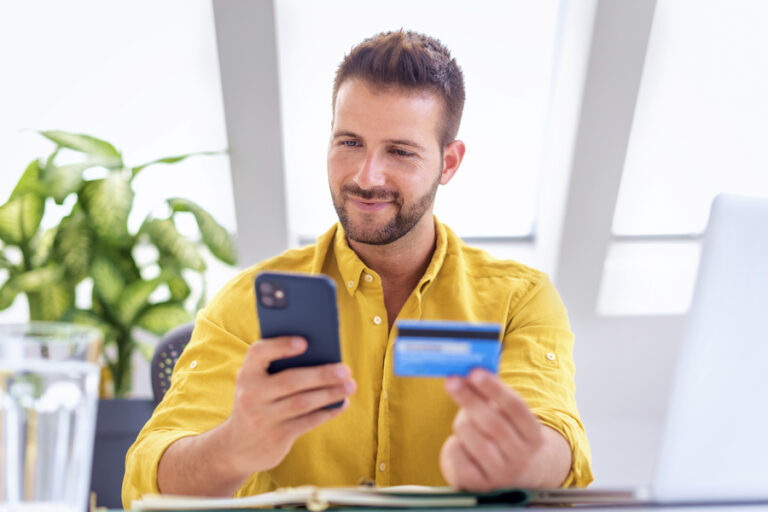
[332,217,448,295]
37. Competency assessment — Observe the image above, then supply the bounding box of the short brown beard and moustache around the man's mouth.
[331,174,440,245]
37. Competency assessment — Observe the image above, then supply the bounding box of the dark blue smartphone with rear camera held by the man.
[254,272,343,407]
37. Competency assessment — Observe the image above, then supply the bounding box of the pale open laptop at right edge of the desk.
[539,195,768,504]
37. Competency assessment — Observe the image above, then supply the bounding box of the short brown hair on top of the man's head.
[333,30,464,148]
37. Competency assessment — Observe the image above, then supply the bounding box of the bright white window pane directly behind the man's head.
[275,0,559,240]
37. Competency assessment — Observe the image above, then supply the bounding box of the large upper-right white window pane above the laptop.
[613,0,768,235]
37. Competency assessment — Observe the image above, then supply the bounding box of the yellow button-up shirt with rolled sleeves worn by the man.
[123,221,592,506]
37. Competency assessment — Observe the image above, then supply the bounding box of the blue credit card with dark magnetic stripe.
[394,320,501,377]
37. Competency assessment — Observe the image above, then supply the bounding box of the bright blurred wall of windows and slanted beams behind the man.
[0,0,768,486]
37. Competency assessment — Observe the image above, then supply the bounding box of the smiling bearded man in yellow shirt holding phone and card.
[123,31,592,505]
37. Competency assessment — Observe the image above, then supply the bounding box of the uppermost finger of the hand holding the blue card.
[467,368,544,446]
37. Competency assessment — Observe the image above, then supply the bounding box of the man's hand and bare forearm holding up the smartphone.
[157,336,356,496]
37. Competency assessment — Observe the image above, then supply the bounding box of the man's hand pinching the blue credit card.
[440,369,571,492]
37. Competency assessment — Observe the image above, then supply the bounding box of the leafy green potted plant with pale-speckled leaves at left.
[0,131,235,396]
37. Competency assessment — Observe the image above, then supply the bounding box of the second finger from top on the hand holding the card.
[446,379,522,459]
